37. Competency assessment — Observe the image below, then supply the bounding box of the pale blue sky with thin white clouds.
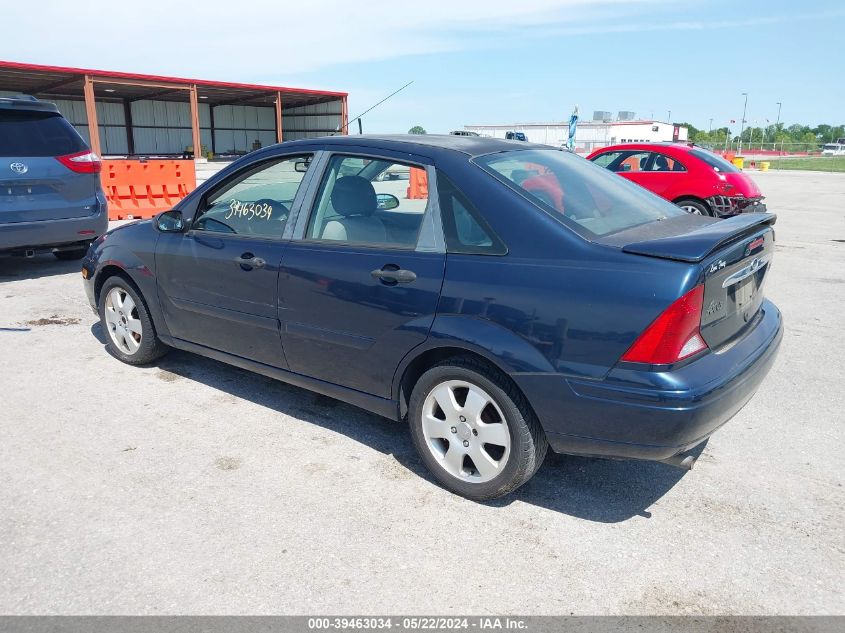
[6,0,845,132]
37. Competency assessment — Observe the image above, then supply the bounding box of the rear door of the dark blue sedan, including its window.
[279,152,446,398]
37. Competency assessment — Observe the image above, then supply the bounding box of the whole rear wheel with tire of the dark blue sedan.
[408,359,548,501]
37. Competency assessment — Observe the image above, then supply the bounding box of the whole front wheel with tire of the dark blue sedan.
[99,277,168,365]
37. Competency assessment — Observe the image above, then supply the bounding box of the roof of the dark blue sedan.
[277,134,558,156]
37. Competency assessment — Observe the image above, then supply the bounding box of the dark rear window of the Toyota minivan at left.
[0,110,86,157]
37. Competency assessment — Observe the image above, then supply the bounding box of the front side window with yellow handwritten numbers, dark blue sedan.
[192,154,311,238]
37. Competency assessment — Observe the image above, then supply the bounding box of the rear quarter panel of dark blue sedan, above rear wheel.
[432,246,695,379]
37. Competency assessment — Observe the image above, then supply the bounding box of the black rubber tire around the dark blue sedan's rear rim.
[408,358,548,501]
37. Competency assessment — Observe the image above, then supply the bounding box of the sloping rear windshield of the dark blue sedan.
[475,149,684,239]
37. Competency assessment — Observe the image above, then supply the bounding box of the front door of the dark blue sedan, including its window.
[156,154,311,368]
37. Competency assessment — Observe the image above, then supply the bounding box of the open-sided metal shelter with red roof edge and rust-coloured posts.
[0,61,348,158]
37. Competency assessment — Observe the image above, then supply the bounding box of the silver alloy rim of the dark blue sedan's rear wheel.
[422,380,511,483]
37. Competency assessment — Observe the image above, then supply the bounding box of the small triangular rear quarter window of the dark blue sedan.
[437,171,508,255]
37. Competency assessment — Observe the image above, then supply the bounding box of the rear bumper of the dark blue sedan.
[514,301,783,460]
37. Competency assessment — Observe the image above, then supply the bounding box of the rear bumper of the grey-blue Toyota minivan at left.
[0,204,109,255]
